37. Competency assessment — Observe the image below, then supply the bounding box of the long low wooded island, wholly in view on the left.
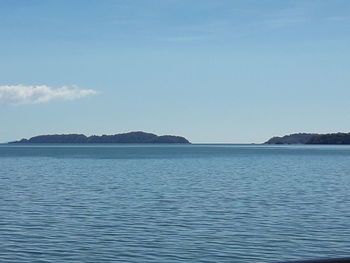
[10,131,190,144]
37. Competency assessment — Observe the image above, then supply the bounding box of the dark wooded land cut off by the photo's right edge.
[265,132,350,144]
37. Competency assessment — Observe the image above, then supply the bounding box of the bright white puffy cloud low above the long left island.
[0,85,96,104]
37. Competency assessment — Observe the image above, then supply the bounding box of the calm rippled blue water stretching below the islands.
[0,145,350,263]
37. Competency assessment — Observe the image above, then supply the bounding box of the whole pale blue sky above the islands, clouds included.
[0,0,350,143]
